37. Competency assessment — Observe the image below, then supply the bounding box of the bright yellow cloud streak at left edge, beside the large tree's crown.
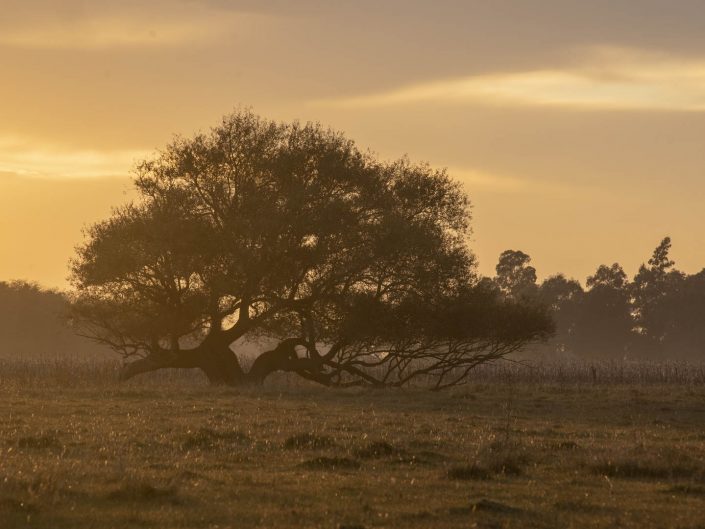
[0,136,149,178]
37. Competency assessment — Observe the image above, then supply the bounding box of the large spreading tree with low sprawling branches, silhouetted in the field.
[72,111,551,388]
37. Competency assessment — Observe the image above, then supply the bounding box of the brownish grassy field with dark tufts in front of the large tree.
[0,363,705,529]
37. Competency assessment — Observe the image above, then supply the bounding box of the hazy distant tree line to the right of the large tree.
[486,237,705,360]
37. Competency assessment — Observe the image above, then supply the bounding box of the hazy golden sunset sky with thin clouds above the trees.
[0,0,705,287]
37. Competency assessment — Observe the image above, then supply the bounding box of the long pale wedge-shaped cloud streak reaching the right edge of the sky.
[317,49,705,112]
